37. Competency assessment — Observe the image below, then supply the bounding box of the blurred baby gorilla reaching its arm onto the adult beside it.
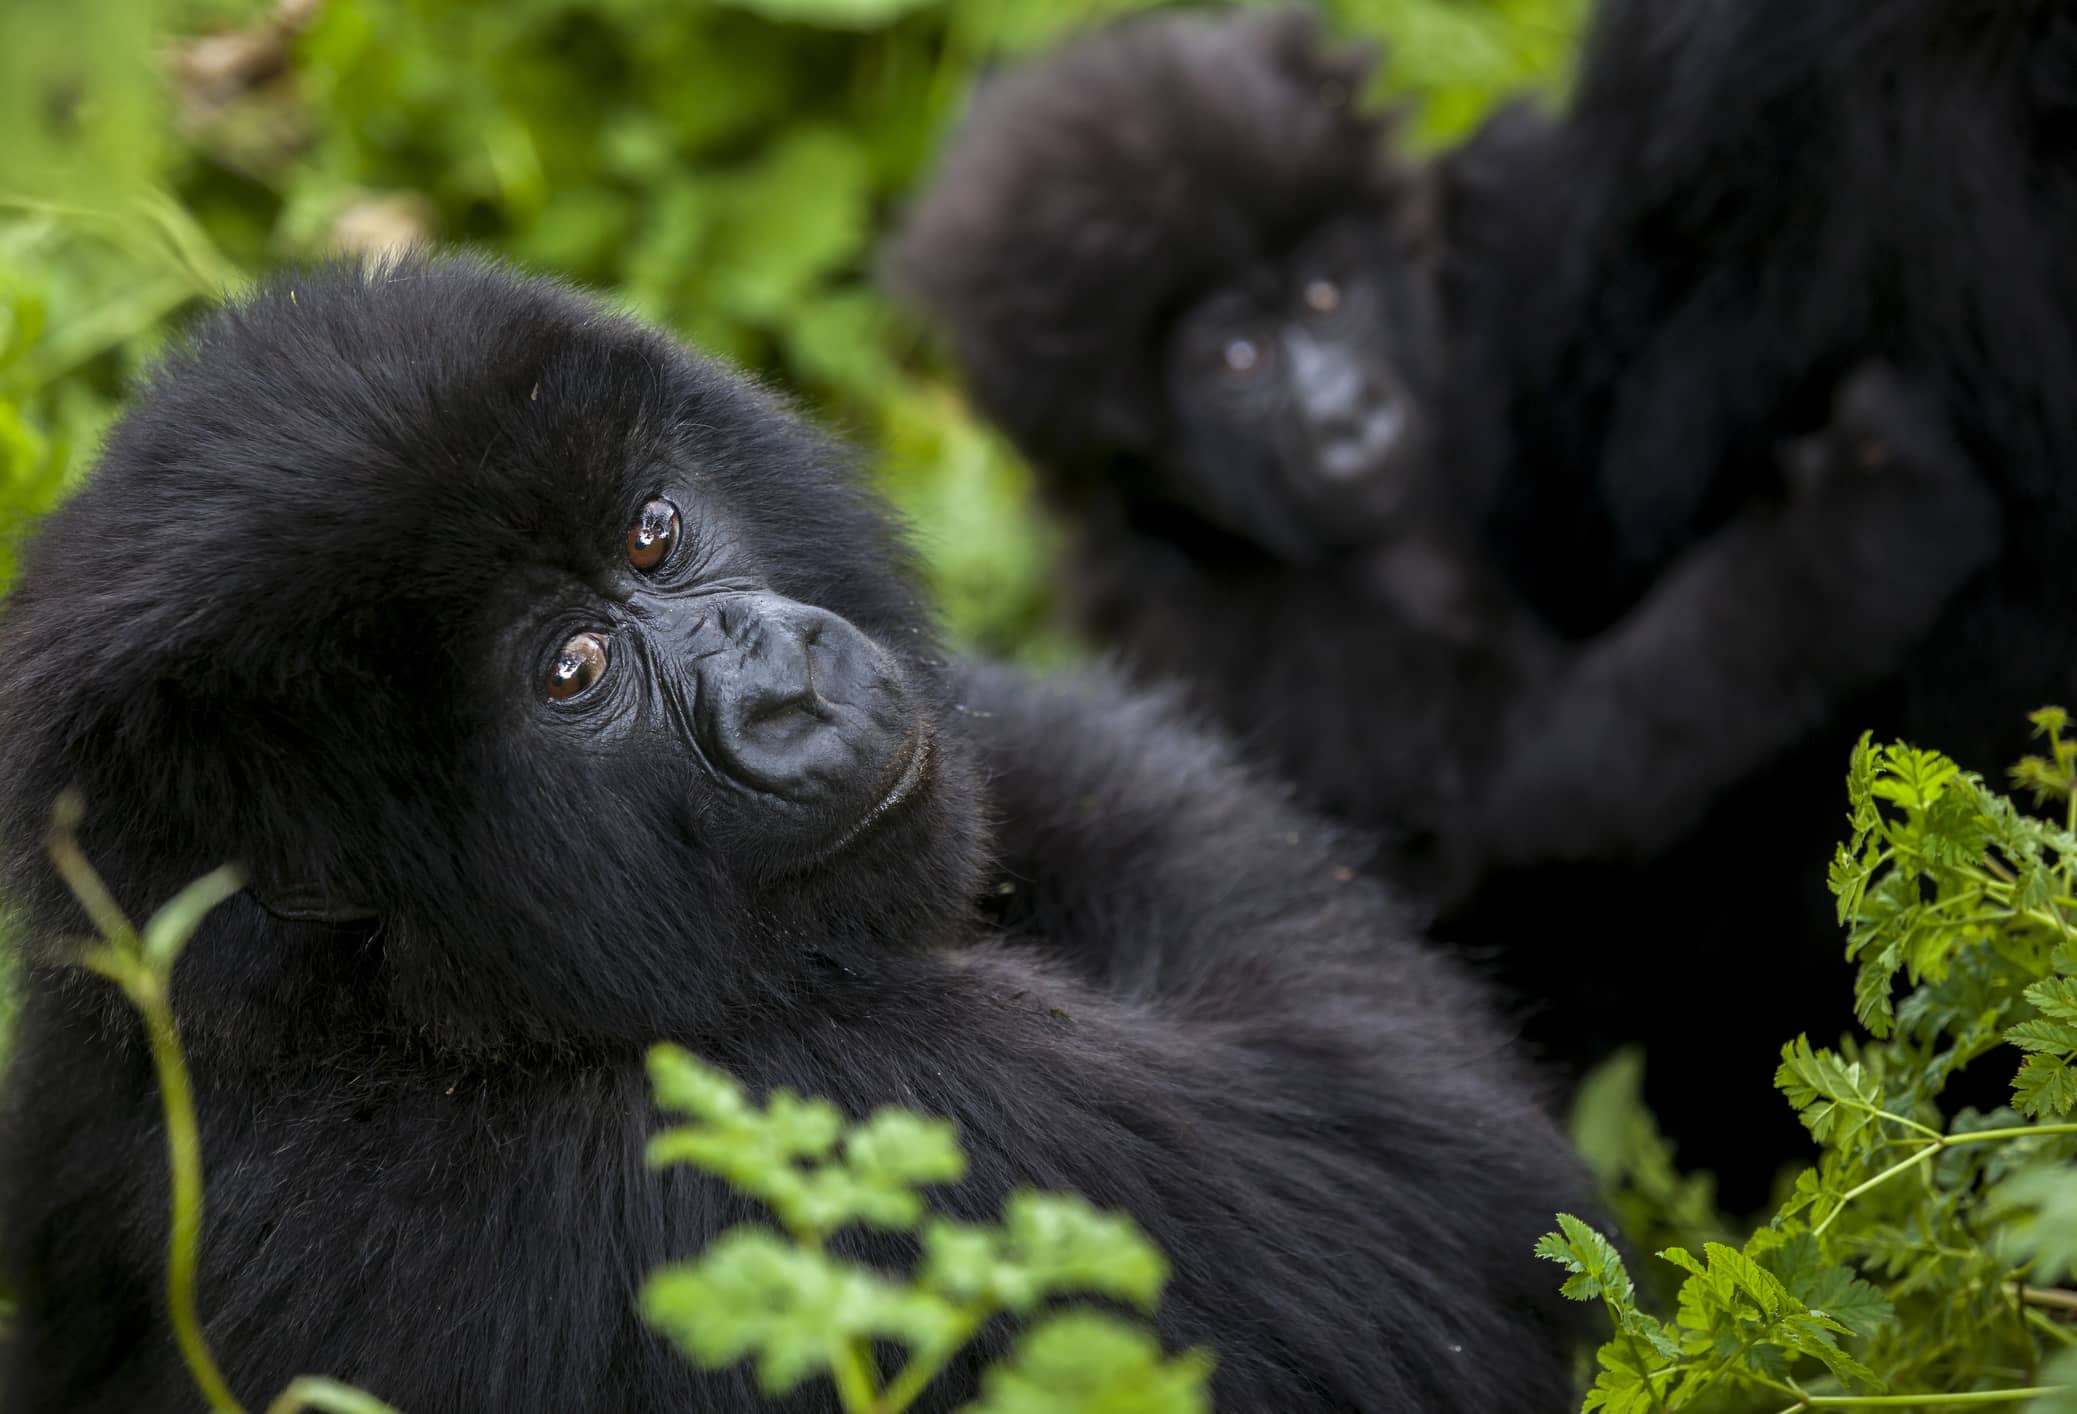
[889,2,2000,1204]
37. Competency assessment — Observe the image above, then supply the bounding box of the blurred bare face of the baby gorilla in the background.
[1165,218,1439,559]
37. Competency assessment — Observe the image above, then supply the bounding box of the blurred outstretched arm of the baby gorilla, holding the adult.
[1462,370,2002,866]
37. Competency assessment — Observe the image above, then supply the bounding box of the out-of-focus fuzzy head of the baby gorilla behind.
[889,10,1441,561]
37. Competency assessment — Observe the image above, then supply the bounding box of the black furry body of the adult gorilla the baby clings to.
[1444,0,2077,1171]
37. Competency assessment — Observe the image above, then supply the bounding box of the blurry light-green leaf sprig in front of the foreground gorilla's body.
[642,1046,1211,1414]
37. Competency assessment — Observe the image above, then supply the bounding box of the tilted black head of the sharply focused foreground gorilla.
[0,253,980,1036]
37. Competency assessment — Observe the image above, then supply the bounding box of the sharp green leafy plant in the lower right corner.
[1537,710,2077,1414]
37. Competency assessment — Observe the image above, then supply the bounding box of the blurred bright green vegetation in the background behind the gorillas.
[0,0,1581,662]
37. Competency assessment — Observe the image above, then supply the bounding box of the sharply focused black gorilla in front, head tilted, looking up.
[0,262,1581,1414]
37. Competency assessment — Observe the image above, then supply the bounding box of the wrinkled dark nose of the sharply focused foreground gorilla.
[698,594,906,801]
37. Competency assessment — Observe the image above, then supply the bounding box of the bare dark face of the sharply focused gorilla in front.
[521,484,935,872]
